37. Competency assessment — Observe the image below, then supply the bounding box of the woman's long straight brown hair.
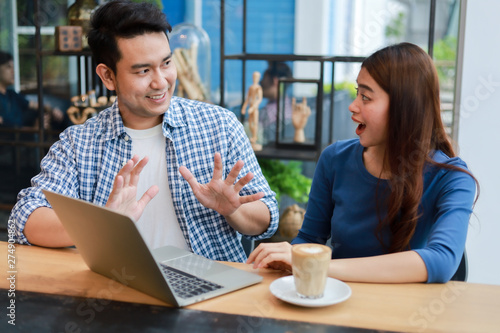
[362,43,477,253]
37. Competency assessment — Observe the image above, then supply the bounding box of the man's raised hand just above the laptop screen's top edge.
[106,155,159,221]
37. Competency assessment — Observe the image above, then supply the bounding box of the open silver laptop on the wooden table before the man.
[43,190,262,306]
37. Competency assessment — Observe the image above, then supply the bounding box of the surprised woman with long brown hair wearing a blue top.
[247,43,476,283]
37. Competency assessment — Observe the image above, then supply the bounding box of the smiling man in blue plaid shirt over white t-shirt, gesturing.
[11,0,278,261]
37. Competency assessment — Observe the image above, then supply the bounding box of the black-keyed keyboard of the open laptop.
[161,264,222,298]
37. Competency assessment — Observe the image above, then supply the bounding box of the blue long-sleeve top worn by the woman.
[292,139,476,283]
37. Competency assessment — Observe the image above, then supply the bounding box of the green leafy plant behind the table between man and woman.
[259,159,312,203]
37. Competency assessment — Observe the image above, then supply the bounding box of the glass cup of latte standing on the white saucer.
[292,244,332,299]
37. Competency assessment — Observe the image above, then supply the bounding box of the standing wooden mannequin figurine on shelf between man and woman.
[241,72,262,151]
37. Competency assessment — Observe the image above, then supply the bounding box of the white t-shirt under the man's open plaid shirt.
[125,124,189,250]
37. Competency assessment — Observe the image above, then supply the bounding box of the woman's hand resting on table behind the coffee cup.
[247,242,292,272]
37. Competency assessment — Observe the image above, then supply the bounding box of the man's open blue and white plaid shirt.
[10,97,278,262]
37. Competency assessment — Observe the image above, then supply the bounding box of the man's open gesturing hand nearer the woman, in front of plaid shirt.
[179,153,264,218]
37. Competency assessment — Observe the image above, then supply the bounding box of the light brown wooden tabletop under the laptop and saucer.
[0,242,500,333]
